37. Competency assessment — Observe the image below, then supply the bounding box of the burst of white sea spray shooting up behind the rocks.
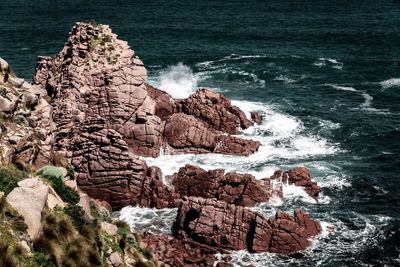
[158,62,198,98]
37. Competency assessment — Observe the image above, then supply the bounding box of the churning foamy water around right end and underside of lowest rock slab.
[223,213,391,267]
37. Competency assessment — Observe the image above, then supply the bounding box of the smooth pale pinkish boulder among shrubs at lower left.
[7,178,49,239]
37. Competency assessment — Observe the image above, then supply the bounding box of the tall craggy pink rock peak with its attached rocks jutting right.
[33,23,260,209]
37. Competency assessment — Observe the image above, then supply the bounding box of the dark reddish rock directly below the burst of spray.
[177,89,253,134]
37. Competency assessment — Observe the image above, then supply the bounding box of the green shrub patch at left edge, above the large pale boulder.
[0,165,28,195]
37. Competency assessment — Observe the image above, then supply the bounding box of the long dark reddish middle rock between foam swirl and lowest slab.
[171,164,271,207]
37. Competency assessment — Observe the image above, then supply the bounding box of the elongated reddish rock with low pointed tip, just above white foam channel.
[164,113,261,156]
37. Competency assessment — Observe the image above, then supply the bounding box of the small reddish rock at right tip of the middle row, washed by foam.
[270,167,321,200]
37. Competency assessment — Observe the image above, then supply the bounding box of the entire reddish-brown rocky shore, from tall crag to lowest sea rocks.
[0,23,322,266]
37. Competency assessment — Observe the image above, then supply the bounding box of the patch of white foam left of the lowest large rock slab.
[114,206,177,234]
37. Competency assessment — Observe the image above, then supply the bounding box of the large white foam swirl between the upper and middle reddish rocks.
[144,101,340,182]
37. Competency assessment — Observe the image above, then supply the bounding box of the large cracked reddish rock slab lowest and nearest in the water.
[174,197,321,253]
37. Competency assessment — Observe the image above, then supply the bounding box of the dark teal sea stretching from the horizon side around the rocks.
[0,0,400,266]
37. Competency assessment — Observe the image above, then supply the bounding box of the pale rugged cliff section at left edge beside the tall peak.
[0,58,54,168]
